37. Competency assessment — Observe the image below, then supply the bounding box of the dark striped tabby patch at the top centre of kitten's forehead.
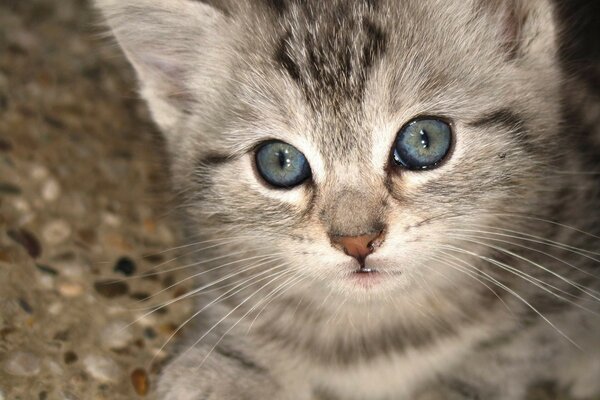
[273,2,388,105]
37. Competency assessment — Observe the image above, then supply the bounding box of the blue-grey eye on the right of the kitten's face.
[394,118,452,170]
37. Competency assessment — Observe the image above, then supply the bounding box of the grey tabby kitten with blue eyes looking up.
[96,0,600,400]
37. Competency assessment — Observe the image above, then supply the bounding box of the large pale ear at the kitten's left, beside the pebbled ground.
[95,0,226,131]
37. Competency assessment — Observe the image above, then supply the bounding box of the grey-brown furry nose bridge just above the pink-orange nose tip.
[320,185,384,237]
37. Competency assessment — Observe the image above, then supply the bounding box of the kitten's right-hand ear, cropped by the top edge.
[477,0,557,60]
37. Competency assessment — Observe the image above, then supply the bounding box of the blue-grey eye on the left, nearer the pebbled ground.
[256,141,311,188]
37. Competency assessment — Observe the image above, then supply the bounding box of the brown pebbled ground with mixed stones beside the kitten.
[0,0,596,400]
